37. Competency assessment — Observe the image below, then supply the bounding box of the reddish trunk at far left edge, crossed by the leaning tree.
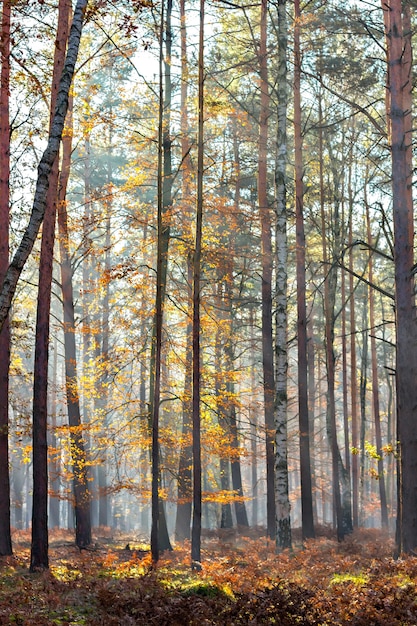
[0,0,12,556]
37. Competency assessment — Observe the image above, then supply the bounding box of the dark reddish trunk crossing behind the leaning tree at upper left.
[30,0,70,572]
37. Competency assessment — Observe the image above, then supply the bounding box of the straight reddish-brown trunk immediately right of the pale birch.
[294,0,314,539]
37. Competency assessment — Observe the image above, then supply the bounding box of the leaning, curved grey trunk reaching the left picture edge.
[0,0,88,336]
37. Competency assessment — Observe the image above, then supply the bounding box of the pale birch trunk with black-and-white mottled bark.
[274,0,291,550]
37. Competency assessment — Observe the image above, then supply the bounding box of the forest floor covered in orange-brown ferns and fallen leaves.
[0,529,417,626]
